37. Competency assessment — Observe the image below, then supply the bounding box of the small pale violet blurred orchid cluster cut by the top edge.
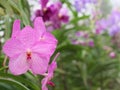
[74,0,97,12]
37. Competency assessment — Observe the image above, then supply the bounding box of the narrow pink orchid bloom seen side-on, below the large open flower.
[41,53,59,90]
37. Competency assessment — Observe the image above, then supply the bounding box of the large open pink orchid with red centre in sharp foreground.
[3,17,57,75]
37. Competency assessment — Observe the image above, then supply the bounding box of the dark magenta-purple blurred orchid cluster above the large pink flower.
[32,0,69,31]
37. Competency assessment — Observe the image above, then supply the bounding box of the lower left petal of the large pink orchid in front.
[9,54,29,75]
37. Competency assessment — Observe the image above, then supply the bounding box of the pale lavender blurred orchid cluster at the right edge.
[96,10,120,36]
